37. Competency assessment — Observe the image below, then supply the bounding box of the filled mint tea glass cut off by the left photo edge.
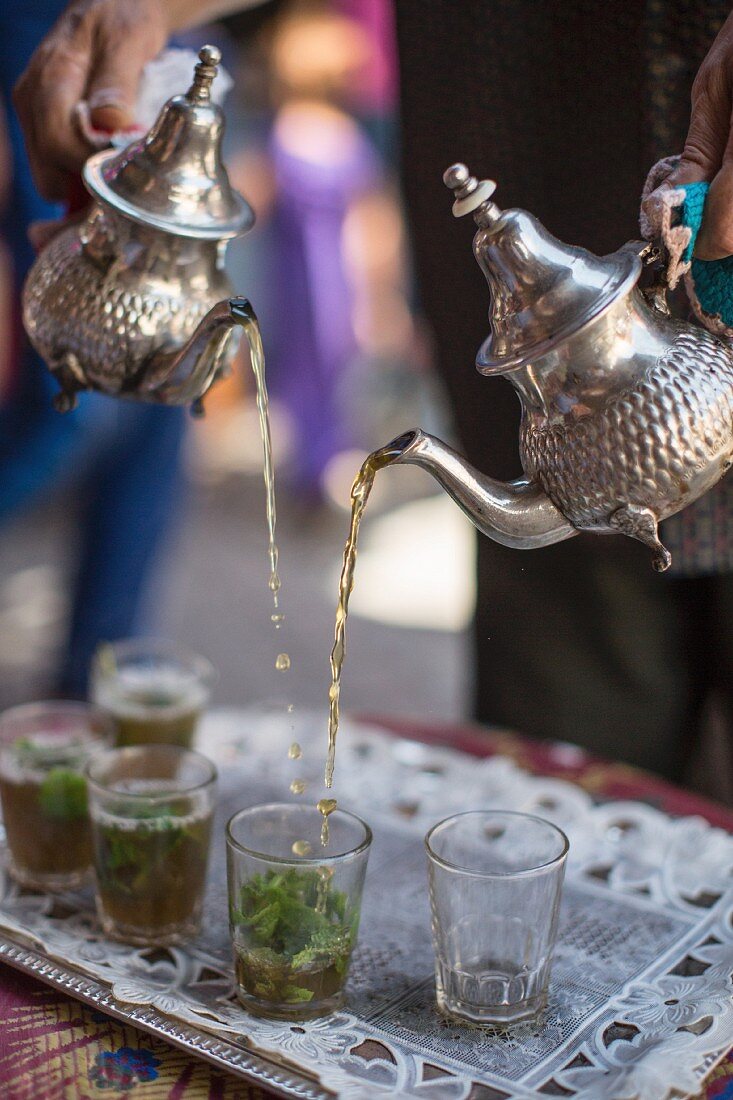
[0,701,113,890]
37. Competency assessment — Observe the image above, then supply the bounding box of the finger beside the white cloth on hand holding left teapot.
[87,29,162,133]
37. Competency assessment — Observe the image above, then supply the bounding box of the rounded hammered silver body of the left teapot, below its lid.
[23,206,231,394]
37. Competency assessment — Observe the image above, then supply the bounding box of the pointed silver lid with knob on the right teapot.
[442,164,642,374]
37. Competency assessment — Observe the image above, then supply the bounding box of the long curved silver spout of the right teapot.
[387,428,578,550]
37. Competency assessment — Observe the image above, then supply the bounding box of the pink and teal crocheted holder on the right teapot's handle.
[639,156,733,340]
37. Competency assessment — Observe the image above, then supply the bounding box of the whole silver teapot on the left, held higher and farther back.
[23,46,259,413]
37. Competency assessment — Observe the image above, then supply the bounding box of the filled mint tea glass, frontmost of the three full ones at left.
[87,745,217,947]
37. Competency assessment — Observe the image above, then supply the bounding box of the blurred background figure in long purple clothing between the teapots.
[269,8,383,501]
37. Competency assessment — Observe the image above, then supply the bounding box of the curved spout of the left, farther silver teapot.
[139,298,259,405]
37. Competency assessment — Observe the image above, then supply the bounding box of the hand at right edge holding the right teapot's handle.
[668,13,733,260]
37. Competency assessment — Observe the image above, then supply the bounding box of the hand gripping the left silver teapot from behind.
[13,0,169,201]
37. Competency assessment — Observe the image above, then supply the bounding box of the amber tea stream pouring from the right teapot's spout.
[326,433,412,787]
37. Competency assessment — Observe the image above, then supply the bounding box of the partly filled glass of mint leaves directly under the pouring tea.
[227,803,372,1020]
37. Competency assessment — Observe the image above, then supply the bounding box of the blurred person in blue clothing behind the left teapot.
[0,0,186,697]
